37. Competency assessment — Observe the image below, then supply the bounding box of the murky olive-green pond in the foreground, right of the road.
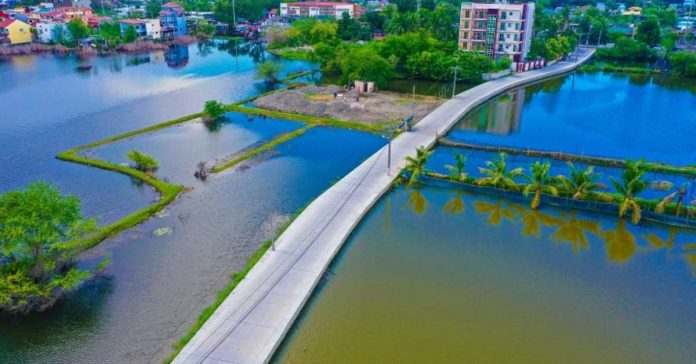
[274,187,696,363]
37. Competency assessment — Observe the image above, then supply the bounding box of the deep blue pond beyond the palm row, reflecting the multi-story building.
[448,73,696,165]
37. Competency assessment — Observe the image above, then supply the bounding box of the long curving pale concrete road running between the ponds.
[174,48,594,363]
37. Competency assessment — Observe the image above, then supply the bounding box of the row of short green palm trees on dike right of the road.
[403,147,672,224]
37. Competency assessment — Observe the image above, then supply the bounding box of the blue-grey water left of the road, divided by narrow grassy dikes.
[0,42,385,363]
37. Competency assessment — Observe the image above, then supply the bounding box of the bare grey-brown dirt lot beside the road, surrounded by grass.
[254,86,444,124]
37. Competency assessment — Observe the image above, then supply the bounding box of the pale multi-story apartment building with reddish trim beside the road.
[459,2,534,62]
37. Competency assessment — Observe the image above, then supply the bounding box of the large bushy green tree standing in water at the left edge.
[0,182,100,313]
